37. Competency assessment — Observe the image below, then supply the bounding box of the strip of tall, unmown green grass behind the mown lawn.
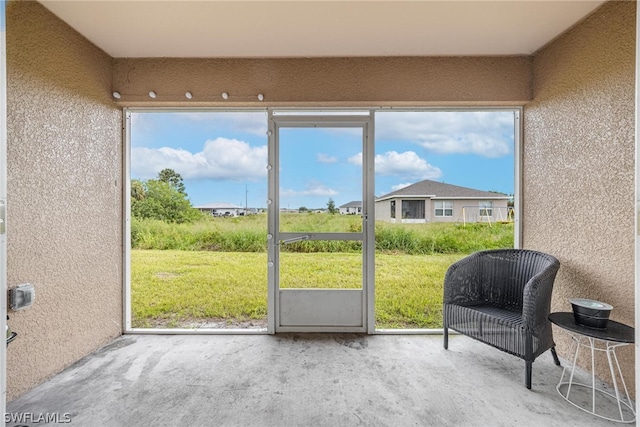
[131,213,513,255]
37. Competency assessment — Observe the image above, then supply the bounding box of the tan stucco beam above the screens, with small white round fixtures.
[113,56,531,107]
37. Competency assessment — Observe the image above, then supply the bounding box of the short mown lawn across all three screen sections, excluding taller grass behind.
[131,250,463,328]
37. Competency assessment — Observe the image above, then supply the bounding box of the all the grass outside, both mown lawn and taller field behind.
[131,214,513,328]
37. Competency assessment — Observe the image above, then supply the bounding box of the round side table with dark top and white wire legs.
[549,312,636,423]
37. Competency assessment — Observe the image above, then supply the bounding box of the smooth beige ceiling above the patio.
[40,0,604,58]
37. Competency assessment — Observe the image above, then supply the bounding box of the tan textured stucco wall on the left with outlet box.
[7,2,122,402]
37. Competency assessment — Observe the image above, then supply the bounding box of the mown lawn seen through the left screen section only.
[131,250,267,328]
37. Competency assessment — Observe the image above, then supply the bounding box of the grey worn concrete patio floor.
[7,334,636,427]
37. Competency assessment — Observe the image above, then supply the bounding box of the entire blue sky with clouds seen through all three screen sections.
[131,111,514,209]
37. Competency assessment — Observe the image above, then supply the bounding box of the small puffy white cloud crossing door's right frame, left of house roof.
[348,151,442,179]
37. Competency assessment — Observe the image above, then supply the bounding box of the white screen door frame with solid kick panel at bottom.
[267,111,375,333]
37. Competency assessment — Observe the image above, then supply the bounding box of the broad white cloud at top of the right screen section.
[376,111,514,157]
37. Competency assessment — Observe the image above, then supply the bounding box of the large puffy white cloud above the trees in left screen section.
[131,138,267,181]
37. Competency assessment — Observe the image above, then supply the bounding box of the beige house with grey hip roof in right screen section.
[375,180,512,223]
